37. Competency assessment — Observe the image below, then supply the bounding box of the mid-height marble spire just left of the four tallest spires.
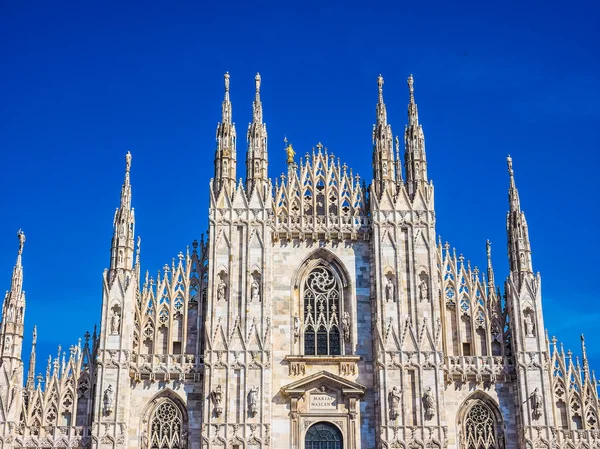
[110,151,135,279]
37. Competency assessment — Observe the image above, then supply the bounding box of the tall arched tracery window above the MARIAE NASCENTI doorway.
[303,266,342,355]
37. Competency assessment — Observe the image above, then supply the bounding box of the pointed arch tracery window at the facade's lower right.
[461,400,503,449]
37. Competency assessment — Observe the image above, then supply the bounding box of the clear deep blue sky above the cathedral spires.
[0,1,600,378]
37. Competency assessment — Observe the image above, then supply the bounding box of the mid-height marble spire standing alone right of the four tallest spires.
[506,156,533,282]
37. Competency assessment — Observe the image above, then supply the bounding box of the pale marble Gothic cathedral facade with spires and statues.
[0,74,600,449]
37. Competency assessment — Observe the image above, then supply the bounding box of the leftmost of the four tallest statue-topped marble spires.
[213,72,236,195]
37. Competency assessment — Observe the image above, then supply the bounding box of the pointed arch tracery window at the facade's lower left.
[150,400,184,449]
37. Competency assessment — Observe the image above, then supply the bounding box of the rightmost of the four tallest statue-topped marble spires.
[404,75,427,196]
